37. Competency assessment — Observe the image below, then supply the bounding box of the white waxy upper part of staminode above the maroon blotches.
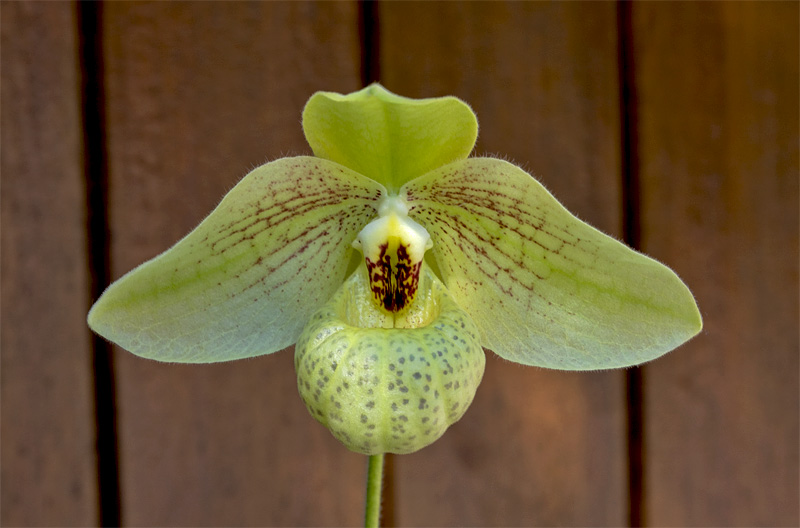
[353,196,433,263]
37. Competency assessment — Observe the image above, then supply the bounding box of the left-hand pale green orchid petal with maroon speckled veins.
[88,157,385,363]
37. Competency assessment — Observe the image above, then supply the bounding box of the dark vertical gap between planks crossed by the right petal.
[617,0,645,526]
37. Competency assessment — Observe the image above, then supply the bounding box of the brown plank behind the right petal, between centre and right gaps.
[380,2,627,526]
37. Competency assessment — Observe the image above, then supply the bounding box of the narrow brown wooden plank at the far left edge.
[0,2,98,526]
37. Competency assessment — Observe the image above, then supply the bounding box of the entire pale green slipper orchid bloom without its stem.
[89,85,702,454]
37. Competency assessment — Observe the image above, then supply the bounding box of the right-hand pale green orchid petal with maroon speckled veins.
[403,158,702,370]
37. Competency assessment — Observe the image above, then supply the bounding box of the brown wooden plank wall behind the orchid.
[0,2,800,526]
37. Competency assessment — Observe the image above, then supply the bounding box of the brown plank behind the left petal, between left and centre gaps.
[104,2,366,526]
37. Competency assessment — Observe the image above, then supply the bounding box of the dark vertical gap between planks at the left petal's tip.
[76,2,122,526]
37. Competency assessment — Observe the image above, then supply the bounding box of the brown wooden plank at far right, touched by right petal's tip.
[633,2,800,526]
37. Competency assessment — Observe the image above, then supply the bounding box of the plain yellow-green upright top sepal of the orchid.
[303,84,478,192]
